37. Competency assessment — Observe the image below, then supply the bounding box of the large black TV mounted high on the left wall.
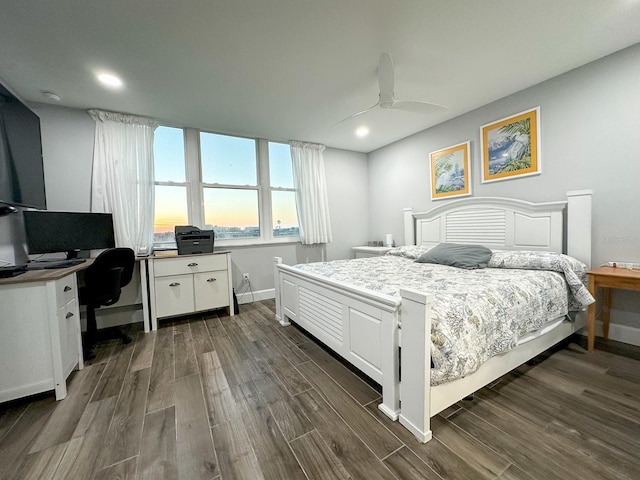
[0,80,47,209]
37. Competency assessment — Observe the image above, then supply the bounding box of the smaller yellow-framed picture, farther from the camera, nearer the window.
[429,141,471,200]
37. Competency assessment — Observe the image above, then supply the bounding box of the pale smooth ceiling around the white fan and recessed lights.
[0,0,640,152]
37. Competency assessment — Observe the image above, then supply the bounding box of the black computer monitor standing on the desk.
[23,210,115,258]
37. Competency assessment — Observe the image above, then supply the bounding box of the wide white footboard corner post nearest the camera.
[400,288,431,443]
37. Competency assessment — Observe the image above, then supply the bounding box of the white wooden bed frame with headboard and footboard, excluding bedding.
[274,190,591,442]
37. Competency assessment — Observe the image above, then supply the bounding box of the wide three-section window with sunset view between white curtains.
[154,126,299,246]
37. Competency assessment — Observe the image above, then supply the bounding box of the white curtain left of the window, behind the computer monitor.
[89,110,158,255]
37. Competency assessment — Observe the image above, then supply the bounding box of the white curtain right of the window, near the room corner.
[289,141,332,245]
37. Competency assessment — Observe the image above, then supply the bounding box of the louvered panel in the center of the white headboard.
[445,210,507,245]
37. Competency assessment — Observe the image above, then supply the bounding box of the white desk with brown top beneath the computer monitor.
[0,260,91,402]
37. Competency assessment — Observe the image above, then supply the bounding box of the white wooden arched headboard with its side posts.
[404,190,592,266]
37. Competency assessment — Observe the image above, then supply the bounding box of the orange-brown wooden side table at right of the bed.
[587,267,640,351]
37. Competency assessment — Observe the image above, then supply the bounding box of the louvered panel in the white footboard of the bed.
[298,287,344,344]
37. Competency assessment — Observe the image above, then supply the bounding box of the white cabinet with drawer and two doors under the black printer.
[147,252,233,330]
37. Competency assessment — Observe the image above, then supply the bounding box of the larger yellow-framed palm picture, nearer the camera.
[480,107,542,183]
